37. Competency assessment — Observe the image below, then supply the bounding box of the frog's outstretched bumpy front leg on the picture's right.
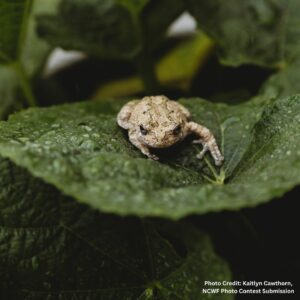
[187,122,224,166]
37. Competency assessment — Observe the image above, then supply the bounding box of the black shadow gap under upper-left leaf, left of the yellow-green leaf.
[36,58,135,106]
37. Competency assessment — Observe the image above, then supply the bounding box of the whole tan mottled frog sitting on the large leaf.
[117,96,224,166]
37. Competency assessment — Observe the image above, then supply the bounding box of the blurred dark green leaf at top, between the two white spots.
[39,0,148,59]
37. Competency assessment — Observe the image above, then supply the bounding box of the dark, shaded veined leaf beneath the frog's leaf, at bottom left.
[0,158,233,300]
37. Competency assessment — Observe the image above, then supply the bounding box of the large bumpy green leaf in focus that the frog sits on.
[0,96,300,218]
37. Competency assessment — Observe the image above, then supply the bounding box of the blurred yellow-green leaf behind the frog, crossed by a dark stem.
[95,33,214,98]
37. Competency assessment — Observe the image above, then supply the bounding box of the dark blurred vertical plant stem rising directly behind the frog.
[137,49,160,95]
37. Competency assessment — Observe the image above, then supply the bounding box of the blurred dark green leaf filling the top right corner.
[187,0,300,67]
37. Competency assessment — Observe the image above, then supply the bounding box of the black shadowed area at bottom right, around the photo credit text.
[190,187,300,299]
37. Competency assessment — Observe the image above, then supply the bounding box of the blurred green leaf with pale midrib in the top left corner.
[0,0,58,118]
